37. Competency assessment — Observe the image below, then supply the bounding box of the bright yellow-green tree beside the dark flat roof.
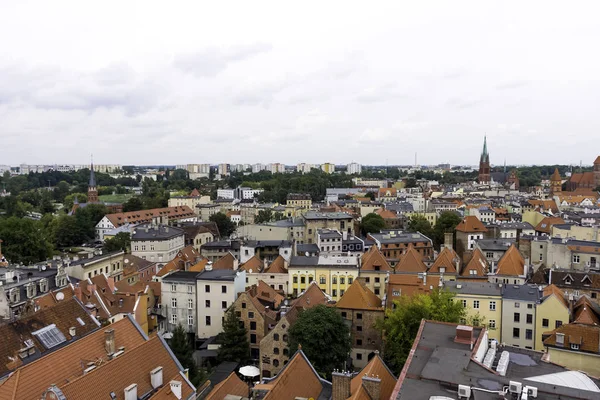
[377,288,466,373]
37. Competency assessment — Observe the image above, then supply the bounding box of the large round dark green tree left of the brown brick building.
[289,305,352,377]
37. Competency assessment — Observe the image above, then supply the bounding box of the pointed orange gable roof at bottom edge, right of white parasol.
[254,350,331,400]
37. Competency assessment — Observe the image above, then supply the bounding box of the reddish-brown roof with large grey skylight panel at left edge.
[0,298,100,378]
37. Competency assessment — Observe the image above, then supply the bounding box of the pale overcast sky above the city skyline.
[0,0,600,164]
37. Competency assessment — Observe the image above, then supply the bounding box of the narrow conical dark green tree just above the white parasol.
[217,307,250,364]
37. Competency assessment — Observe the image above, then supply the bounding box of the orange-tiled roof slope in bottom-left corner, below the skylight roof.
[0,317,145,400]
